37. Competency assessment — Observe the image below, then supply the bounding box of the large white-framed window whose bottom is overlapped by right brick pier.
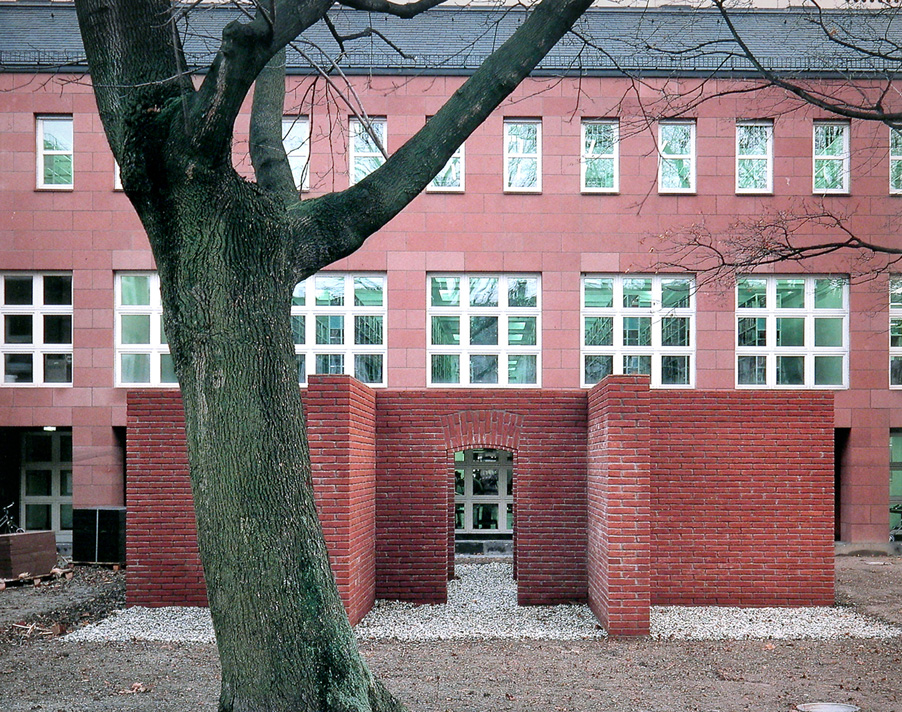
[580,274,695,388]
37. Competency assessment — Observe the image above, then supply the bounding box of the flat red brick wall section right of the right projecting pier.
[651,391,834,606]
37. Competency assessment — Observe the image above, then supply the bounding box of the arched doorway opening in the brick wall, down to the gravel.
[454,448,514,555]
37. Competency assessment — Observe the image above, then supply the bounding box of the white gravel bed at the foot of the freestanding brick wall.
[62,563,902,643]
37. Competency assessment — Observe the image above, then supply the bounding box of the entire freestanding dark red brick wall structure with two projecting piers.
[128,376,833,635]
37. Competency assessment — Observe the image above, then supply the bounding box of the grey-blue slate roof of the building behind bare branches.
[0,0,902,75]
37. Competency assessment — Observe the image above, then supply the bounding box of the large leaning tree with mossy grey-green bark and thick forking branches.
[76,0,590,712]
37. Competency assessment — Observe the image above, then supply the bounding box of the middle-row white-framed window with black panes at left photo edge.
[0,272,72,386]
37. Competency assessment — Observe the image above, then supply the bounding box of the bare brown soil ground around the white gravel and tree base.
[0,557,902,712]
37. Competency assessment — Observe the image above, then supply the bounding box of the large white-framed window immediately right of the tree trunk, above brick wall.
[291,272,388,386]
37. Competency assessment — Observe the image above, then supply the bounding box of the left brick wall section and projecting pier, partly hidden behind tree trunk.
[126,376,376,623]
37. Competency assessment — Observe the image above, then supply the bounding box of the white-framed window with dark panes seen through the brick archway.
[454,448,514,534]
